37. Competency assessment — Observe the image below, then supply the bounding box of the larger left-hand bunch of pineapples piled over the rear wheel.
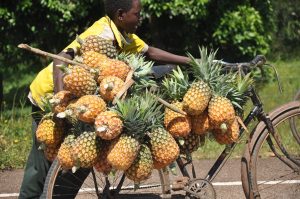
[36,35,179,183]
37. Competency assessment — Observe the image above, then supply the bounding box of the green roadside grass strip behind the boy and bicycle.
[0,60,300,169]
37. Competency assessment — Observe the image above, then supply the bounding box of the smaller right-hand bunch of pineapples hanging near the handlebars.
[162,48,253,153]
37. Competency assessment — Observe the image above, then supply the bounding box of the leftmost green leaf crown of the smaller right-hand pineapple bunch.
[162,67,190,100]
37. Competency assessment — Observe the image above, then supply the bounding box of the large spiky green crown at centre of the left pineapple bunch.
[113,91,163,139]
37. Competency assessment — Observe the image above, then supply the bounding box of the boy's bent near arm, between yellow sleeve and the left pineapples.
[53,48,75,93]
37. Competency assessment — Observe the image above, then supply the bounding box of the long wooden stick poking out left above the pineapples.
[18,44,90,70]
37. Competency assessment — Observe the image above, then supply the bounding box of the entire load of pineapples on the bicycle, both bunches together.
[36,35,250,183]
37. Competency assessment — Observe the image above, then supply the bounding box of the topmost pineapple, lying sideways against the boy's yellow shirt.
[77,35,117,58]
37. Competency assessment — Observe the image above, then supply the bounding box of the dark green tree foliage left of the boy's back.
[0,0,104,107]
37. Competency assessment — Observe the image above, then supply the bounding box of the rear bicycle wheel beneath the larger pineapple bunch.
[41,160,170,199]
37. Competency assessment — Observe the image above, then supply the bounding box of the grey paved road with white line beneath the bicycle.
[0,158,300,199]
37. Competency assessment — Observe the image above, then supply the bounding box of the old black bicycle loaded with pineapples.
[42,56,300,199]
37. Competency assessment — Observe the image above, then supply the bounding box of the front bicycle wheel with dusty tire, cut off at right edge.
[241,101,300,199]
